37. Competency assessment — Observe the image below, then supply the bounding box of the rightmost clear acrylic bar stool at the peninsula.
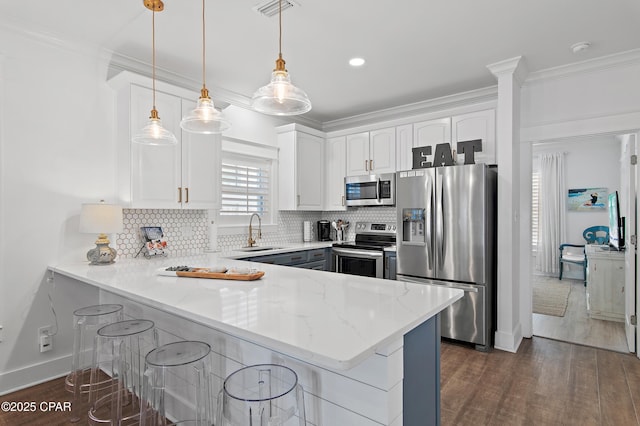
[216,364,307,426]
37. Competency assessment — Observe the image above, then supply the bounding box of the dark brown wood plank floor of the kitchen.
[0,337,640,426]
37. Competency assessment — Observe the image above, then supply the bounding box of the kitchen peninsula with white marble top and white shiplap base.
[49,254,462,426]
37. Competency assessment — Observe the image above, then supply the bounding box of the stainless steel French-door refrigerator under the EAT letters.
[396,164,497,350]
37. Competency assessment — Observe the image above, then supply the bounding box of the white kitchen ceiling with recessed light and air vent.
[0,0,640,123]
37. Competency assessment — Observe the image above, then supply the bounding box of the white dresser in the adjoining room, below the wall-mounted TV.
[585,245,624,322]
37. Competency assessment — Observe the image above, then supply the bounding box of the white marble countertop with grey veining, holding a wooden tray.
[49,253,463,370]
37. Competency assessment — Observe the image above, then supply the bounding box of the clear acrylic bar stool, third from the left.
[140,341,213,426]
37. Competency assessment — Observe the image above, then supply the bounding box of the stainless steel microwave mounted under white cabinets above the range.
[344,173,396,206]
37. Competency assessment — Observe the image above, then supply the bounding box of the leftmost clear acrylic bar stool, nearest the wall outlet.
[65,304,123,423]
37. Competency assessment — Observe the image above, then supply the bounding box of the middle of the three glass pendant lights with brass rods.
[180,0,231,134]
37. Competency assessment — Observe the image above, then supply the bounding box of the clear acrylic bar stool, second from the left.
[88,319,158,425]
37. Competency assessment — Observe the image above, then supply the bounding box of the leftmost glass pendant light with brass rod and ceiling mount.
[131,0,178,145]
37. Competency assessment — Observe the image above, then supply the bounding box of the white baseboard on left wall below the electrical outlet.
[0,355,71,396]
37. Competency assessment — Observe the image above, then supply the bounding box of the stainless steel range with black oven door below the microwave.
[332,222,396,278]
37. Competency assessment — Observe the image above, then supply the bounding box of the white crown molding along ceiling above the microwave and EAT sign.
[322,86,498,132]
